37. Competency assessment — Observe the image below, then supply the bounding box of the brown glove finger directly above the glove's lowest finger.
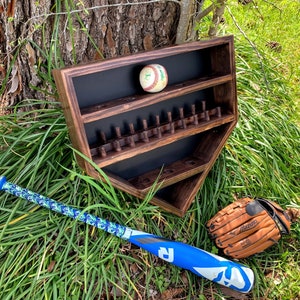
[216,213,274,248]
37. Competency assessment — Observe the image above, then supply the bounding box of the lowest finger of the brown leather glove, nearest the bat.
[224,225,280,258]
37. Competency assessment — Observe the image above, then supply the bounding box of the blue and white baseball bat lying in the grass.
[0,176,254,293]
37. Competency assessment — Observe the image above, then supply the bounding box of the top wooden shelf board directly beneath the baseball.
[81,74,233,123]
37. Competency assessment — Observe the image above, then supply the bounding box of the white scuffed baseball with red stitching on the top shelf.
[140,64,168,93]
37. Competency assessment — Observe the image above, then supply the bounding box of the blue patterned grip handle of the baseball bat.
[0,176,128,239]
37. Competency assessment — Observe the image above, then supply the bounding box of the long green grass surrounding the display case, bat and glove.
[0,1,300,300]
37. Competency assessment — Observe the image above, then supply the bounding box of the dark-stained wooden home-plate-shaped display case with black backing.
[53,36,238,216]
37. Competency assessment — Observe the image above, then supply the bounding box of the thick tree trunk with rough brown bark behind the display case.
[0,0,180,109]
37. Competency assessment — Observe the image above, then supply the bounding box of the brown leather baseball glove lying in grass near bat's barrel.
[207,198,291,258]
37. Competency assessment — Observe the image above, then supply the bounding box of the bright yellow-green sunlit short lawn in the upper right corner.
[223,0,300,119]
